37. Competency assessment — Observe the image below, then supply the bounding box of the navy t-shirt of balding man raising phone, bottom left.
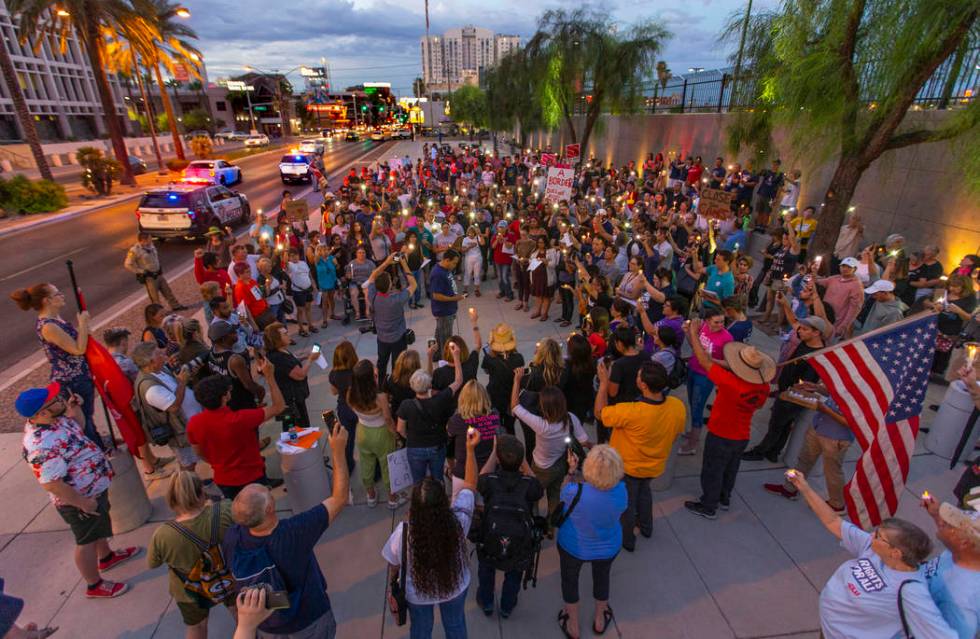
[223,504,330,635]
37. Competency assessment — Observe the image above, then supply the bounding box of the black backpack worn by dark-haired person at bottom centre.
[477,473,540,571]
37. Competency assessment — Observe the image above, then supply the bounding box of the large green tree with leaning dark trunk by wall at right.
[723,0,980,254]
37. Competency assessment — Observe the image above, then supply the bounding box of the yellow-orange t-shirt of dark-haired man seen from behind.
[602,397,687,477]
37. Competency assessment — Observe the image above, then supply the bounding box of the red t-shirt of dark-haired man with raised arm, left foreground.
[187,406,265,486]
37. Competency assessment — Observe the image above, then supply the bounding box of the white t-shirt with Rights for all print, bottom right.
[820,521,957,639]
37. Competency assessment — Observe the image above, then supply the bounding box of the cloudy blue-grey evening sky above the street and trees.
[187,0,776,95]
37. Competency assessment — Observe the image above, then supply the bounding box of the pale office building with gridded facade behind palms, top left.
[0,0,134,141]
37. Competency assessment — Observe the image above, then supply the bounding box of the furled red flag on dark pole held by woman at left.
[65,260,146,457]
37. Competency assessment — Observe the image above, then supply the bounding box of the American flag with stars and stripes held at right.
[810,313,936,529]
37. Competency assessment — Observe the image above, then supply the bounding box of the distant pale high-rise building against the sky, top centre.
[421,25,521,91]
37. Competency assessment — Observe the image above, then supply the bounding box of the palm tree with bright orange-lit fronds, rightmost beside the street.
[133,0,203,160]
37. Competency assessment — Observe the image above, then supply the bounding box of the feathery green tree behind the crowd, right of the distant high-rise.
[526,8,670,162]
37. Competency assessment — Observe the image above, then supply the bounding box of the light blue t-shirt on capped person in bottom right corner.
[928,550,980,639]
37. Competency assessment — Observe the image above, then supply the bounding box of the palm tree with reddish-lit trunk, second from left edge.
[7,0,136,185]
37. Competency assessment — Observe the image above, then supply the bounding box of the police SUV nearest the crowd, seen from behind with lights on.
[136,183,252,238]
